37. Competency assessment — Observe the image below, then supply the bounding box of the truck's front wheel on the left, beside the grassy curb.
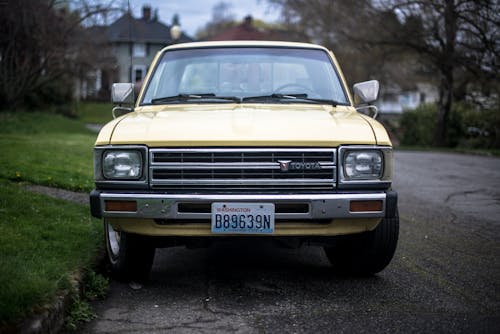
[104,221,156,282]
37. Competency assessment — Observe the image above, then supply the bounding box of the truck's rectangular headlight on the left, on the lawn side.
[102,151,143,180]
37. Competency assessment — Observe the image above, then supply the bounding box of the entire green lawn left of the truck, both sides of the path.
[0,112,103,332]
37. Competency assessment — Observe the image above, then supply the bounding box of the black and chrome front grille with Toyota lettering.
[149,148,336,191]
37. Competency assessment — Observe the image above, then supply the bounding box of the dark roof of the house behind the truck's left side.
[106,13,193,44]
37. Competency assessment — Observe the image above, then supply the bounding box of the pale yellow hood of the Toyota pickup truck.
[97,104,376,147]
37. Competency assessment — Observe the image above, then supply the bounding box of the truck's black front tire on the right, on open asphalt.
[324,210,399,276]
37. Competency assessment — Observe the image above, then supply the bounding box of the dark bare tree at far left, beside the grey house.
[0,0,122,109]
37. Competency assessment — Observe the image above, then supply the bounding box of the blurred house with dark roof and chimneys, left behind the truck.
[77,6,193,99]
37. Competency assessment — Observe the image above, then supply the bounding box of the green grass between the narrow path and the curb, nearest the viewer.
[0,179,103,325]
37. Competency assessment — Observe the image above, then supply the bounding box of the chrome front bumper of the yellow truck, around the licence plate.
[90,191,390,220]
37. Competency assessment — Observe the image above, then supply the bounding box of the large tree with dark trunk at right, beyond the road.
[374,0,500,146]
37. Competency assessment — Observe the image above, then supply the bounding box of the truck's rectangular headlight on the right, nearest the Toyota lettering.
[344,150,384,180]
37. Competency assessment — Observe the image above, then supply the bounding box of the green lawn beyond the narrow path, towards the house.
[0,113,97,191]
